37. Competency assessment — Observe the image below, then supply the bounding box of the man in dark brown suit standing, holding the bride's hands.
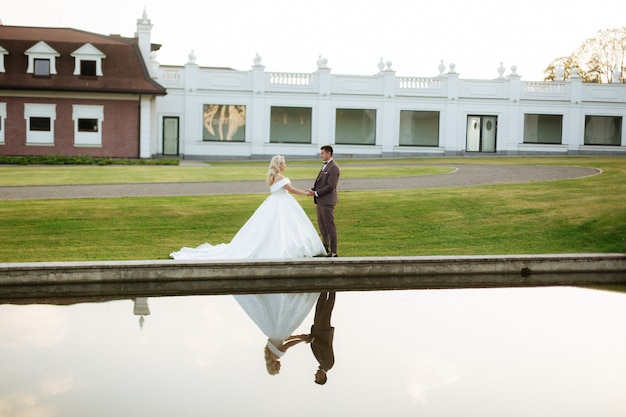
[309,145,340,258]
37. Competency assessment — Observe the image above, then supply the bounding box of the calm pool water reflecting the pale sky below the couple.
[0,288,626,417]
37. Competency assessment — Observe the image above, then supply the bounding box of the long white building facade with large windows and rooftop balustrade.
[141,25,626,159]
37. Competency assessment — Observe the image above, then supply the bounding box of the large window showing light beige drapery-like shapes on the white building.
[202,104,246,142]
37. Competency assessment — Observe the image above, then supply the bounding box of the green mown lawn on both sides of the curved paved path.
[0,157,626,262]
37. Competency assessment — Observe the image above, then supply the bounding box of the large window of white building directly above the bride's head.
[270,107,312,143]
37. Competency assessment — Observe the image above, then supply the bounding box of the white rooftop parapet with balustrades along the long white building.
[157,65,626,103]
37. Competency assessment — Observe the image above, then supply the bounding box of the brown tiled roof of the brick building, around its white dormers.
[0,25,166,95]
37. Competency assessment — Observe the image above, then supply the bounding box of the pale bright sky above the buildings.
[0,0,626,81]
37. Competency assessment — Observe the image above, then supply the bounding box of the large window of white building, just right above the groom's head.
[335,109,376,145]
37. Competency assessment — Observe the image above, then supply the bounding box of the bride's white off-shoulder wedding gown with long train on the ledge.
[170,178,326,260]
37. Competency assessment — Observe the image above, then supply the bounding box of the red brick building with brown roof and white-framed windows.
[0,17,166,158]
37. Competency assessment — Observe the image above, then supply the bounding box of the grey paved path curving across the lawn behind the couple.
[0,165,601,200]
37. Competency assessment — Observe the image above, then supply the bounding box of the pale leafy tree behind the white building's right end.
[544,27,626,83]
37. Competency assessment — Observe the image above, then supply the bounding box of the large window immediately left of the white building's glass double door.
[400,110,439,146]
